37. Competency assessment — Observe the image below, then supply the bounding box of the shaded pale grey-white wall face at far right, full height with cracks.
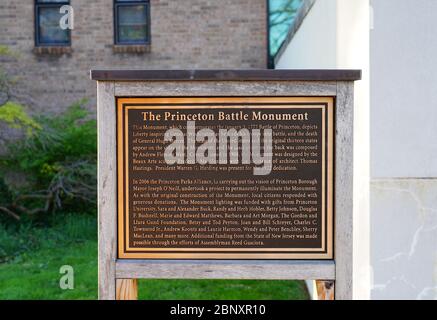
[370,0,437,299]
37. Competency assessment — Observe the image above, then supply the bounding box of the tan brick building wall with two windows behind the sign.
[0,0,268,111]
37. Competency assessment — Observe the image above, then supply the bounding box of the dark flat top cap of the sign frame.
[91,69,361,81]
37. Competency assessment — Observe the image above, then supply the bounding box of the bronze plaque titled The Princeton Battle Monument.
[117,97,334,259]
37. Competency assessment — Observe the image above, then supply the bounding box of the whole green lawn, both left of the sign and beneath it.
[0,215,308,300]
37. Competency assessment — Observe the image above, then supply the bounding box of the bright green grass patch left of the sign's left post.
[0,236,97,299]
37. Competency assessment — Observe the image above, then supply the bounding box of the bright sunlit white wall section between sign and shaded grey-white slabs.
[276,0,371,299]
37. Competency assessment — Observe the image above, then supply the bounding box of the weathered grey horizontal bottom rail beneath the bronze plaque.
[116,260,335,280]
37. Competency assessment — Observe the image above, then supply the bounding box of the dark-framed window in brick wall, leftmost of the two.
[35,0,71,46]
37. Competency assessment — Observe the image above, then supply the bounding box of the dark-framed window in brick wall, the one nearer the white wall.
[114,0,150,45]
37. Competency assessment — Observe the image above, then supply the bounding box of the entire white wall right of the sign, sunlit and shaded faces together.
[277,0,437,299]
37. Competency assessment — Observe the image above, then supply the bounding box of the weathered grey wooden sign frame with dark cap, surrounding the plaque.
[91,70,361,299]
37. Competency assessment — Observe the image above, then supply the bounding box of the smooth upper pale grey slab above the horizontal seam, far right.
[371,0,437,178]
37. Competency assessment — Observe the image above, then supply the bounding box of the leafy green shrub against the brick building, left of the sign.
[0,101,97,220]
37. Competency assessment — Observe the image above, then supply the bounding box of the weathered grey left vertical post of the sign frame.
[97,82,117,300]
